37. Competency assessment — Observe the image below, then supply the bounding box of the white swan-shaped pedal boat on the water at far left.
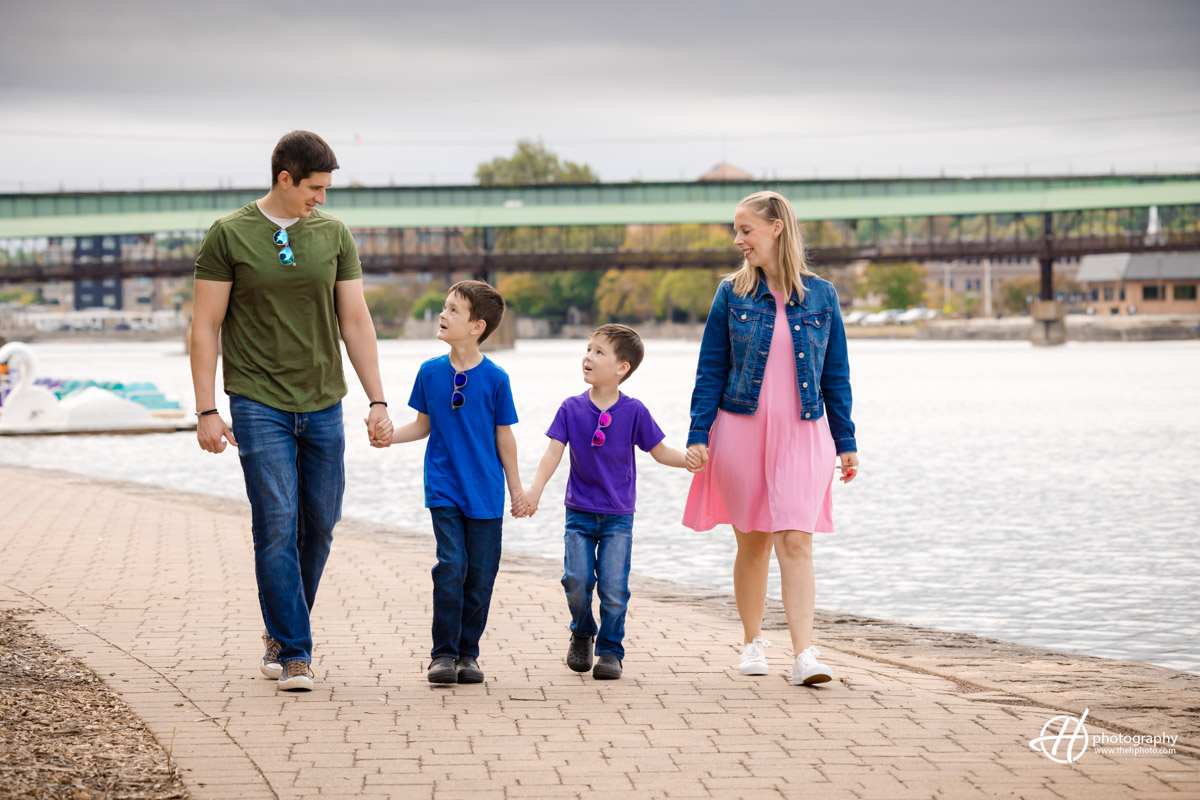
[0,342,196,435]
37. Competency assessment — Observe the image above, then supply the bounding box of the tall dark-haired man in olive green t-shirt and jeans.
[191,131,388,690]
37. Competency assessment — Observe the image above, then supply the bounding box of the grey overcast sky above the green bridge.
[0,0,1200,192]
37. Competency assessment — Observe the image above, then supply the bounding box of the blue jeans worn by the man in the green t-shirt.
[229,395,346,663]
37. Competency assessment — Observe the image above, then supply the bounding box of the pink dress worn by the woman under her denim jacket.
[683,291,838,533]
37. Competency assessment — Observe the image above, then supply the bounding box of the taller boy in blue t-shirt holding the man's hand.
[374,281,524,684]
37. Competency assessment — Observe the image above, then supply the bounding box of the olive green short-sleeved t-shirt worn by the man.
[196,203,362,411]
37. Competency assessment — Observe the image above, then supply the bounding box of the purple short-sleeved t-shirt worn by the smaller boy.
[546,392,666,513]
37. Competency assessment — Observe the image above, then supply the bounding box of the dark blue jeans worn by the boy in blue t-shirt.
[430,506,504,660]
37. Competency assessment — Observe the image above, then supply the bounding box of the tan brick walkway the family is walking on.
[0,467,1200,800]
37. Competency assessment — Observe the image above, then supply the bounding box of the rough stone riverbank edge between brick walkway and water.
[6,464,1200,756]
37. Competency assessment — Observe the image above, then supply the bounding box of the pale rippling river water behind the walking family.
[0,339,1200,672]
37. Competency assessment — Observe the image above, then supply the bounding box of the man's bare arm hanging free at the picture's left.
[191,279,238,453]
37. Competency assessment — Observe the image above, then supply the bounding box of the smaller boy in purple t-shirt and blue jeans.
[524,325,686,680]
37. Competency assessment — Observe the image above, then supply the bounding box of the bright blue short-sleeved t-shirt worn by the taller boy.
[408,354,517,519]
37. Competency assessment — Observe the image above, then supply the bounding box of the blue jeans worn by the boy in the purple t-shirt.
[563,509,634,660]
